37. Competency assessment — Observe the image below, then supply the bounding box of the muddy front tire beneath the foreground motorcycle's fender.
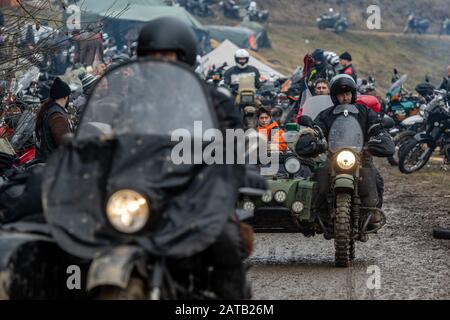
[94,277,148,300]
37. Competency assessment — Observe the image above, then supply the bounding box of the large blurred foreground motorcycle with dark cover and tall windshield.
[0,60,256,300]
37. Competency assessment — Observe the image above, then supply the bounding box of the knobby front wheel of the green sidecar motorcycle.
[334,193,354,268]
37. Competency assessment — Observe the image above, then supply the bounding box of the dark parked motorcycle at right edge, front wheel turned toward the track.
[399,90,450,174]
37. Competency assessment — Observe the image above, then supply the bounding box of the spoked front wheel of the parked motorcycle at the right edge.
[399,140,433,174]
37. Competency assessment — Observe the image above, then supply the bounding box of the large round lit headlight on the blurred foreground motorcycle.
[106,190,150,233]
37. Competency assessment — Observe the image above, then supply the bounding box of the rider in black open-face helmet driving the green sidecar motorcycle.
[296,75,395,229]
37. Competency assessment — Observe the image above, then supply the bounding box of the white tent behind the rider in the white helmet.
[200,40,285,79]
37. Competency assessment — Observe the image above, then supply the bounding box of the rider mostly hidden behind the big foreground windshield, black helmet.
[137,17,251,299]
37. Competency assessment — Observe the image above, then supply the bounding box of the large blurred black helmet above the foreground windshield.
[137,17,197,67]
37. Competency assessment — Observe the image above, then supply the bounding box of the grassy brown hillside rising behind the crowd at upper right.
[203,0,450,95]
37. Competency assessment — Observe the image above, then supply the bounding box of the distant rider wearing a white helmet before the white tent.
[224,49,261,93]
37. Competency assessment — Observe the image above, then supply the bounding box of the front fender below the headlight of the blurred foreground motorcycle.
[86,246,145,291]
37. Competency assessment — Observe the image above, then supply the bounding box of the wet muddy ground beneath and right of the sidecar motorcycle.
[249,161,450,300]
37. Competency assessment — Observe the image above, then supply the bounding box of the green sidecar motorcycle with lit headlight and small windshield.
[241,96,393,267]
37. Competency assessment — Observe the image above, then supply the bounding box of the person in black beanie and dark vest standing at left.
[36,78,72,162]
